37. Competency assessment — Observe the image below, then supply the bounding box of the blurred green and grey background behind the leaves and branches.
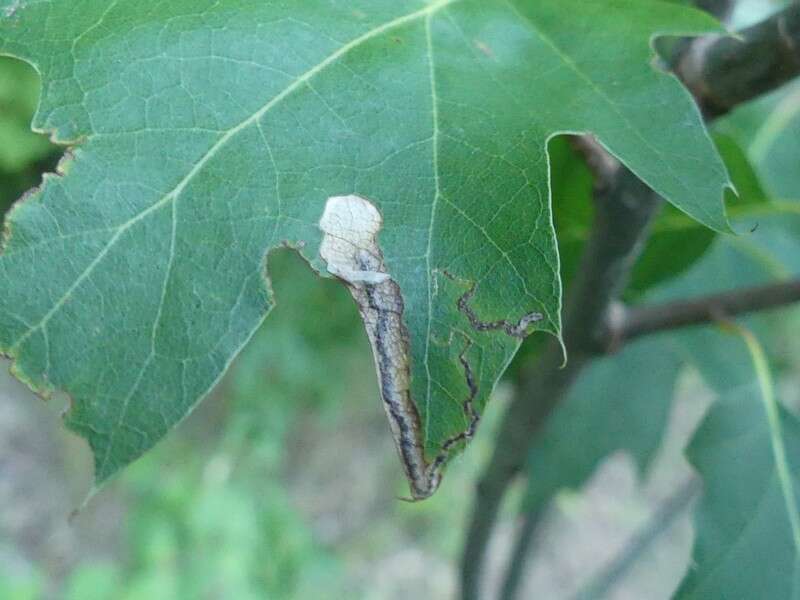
[0,0,800,600]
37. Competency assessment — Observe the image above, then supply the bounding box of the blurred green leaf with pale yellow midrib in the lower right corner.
[677,330,800,598]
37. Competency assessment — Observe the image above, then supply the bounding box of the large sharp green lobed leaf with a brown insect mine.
[0,0,729,497]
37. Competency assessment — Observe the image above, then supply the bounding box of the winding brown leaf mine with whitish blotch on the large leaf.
[319,195,541,501]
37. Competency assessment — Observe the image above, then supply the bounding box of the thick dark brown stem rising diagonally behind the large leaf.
[461,5,800,600]
